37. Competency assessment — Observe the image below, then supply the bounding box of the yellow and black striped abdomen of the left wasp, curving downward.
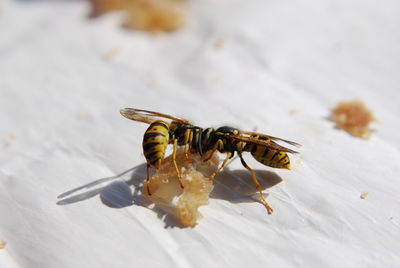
[143,120,169,169]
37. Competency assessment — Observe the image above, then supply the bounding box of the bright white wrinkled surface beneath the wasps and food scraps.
[0,0,400,268]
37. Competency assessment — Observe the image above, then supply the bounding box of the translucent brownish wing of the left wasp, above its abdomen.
[120,108,191,125]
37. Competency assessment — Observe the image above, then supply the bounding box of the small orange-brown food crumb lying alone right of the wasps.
[332,101,375,138]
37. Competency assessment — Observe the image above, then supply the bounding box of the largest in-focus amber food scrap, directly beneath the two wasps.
[143,150,218,227]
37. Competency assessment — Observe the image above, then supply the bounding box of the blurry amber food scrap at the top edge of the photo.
[124,0,184,32]
